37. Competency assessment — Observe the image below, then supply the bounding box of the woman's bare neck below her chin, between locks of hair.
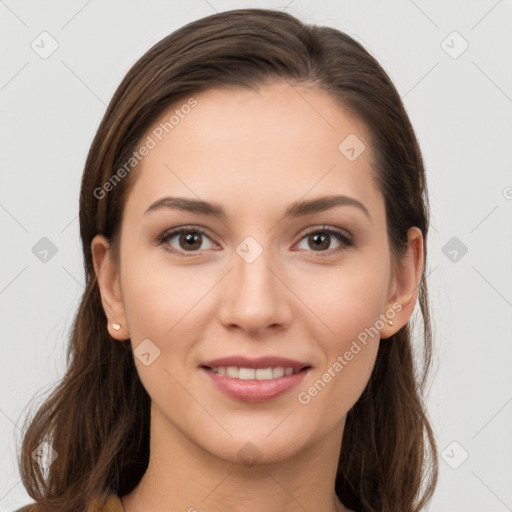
[122,405,350,512]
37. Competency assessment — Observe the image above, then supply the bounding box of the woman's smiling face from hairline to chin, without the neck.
[94,83,418,462]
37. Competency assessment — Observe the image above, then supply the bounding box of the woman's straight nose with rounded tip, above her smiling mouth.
[219,246,293,337]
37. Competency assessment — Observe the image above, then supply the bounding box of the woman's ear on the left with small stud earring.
[91,235,130,340]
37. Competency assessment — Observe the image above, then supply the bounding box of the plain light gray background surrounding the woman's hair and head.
[0,0,512,512]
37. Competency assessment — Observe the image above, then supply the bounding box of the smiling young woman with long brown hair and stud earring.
[20,9,437,512]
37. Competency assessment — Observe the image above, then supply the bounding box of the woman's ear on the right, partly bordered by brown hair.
[380,227,424,339]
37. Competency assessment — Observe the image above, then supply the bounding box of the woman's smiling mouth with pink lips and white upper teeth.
[199,357,312,402]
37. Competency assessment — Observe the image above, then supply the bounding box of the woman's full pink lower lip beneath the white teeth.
[201,368,309,402]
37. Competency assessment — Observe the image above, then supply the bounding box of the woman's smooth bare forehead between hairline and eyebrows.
[122,83,380,220]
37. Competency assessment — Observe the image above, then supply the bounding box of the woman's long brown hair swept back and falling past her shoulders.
[19,9,438,512]
